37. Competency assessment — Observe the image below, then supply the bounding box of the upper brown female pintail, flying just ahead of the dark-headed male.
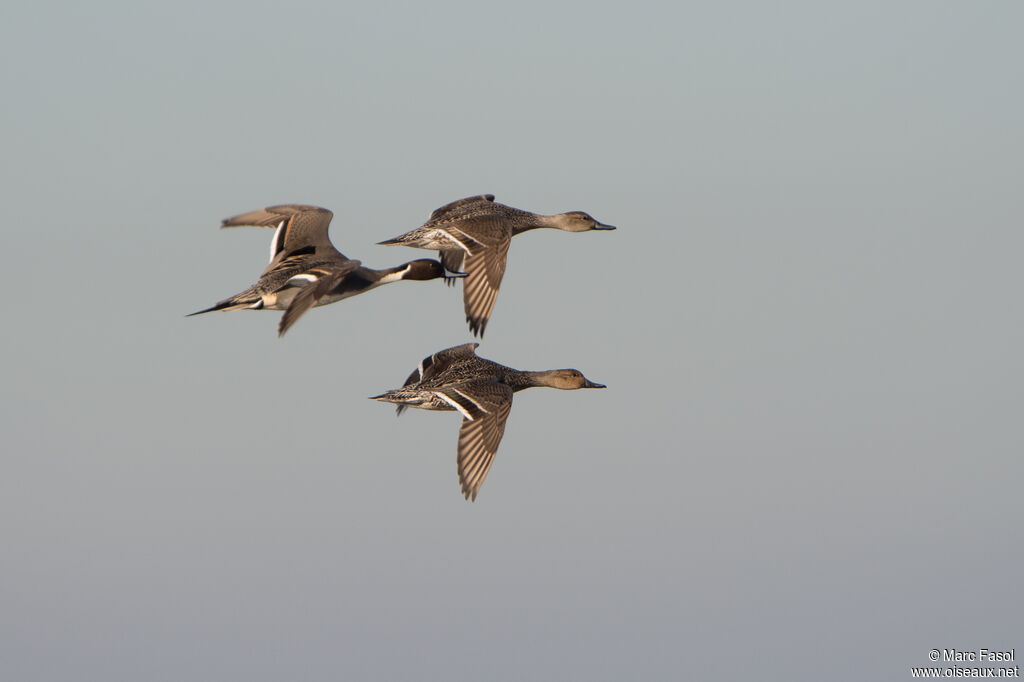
[381,195,614,337]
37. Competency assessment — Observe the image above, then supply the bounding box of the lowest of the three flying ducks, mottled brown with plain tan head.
[372,343,604,501]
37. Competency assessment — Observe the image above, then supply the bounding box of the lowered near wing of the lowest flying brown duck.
[454,381,512,501]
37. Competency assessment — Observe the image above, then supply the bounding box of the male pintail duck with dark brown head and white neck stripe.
[191,204,462,335]
